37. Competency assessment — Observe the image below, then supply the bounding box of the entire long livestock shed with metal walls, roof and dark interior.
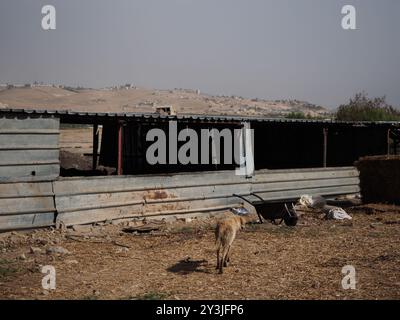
[0,109,400,230]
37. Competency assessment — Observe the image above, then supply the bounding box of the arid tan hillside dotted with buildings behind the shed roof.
[0,86,329,117]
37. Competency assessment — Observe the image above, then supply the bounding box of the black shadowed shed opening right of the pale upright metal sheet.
[252,122,388,170]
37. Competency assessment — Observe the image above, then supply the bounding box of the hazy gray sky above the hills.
[0,0,400,107]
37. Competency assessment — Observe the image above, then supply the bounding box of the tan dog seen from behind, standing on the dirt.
[215,215,251,273]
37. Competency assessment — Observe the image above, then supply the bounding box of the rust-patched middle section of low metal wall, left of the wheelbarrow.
[54,172,248,225]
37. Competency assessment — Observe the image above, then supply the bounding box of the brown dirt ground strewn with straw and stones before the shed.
[0,205,400,299]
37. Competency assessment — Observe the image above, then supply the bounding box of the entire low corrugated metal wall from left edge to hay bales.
[0,167,359,230]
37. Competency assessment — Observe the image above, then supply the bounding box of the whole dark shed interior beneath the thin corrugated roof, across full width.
[1,109,400,175]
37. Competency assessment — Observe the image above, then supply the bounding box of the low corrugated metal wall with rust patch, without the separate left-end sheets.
[54,168,359,225]
